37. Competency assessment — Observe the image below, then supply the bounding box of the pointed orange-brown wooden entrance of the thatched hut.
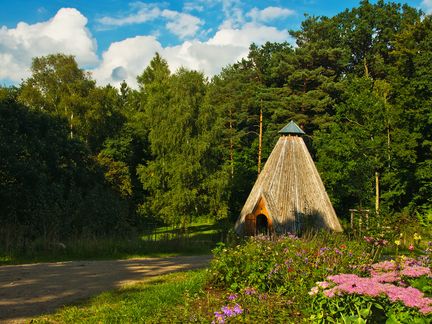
[245,197,273,236]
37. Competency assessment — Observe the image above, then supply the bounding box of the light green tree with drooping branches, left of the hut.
[137,56,230,227]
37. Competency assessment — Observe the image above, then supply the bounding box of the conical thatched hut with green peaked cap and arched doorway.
[235,121,342,235]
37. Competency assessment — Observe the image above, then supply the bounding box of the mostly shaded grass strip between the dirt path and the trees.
[0,221,222,265]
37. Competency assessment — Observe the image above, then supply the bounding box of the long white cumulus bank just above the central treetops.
[93,24,289,87]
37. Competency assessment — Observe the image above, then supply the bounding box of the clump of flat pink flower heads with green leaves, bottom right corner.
[309,258,432,323]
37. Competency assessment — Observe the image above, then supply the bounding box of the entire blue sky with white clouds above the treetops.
[0,0,432,85]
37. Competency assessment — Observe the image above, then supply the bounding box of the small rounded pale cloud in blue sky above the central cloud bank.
[162,9,203,39]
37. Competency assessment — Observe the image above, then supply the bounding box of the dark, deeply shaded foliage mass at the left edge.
[0,84,128,251]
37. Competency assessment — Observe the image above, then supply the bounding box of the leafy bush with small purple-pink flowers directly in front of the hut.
[209,233,370,312]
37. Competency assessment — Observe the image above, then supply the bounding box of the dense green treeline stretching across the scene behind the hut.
[0,1,432,248]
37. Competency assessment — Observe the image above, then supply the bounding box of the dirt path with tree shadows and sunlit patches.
[0,256,210,323]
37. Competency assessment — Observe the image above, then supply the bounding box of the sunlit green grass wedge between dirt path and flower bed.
[32,270,206,323]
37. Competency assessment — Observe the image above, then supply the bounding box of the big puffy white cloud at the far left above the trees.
[0,8,98,82]
